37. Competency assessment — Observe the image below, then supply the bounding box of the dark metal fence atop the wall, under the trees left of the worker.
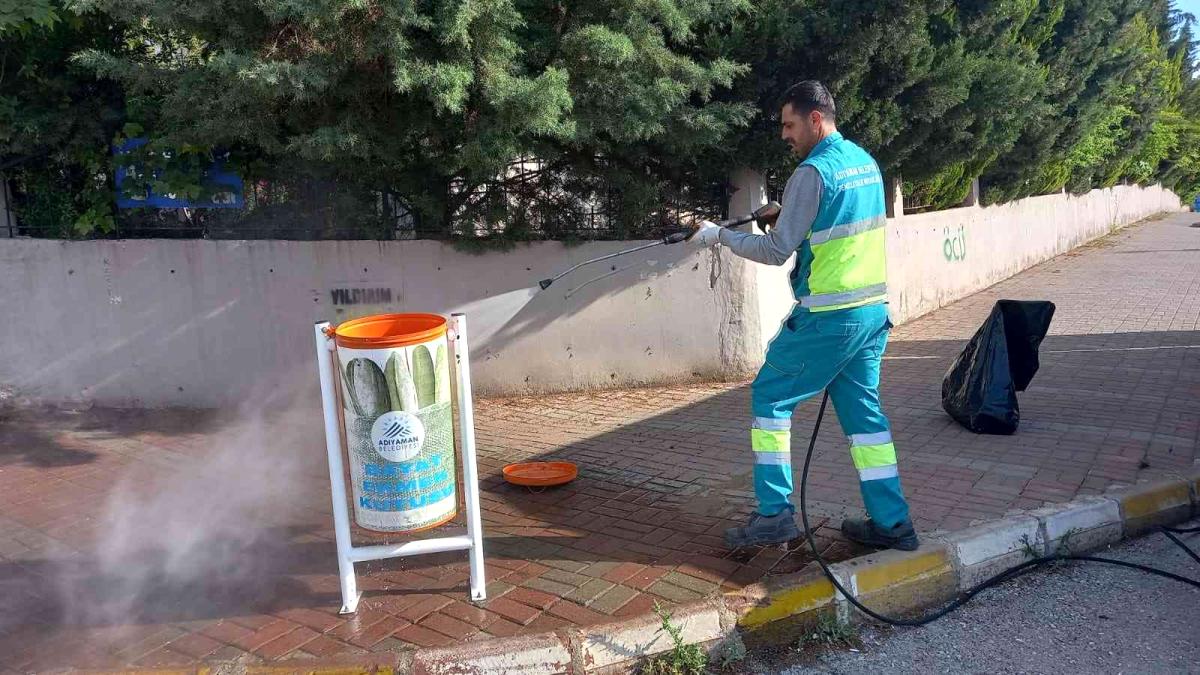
[0,159,730,241]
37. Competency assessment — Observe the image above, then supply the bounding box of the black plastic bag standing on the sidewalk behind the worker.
[942,300,1055,435]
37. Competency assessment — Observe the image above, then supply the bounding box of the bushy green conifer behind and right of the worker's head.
[710,0,1064,207]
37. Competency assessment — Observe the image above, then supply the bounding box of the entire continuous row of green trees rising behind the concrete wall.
[7,0,1200,240]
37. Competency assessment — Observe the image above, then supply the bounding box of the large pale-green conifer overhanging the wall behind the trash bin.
[68,0,748,235]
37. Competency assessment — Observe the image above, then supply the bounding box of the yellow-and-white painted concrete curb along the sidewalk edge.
[171,466,1200,675]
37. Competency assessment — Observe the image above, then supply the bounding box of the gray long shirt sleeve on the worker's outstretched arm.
[720,165,821,265]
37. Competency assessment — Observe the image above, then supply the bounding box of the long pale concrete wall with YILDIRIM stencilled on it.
[0,181,1180,407]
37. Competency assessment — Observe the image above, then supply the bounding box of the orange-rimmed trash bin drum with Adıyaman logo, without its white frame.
[334,313,457,532]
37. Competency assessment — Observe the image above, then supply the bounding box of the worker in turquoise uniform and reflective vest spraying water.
[690,80,918,550]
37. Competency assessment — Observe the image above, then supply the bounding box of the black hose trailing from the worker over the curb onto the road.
[800,390,1200,626]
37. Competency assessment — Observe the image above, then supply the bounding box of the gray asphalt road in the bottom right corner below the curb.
[738,521,1200,675]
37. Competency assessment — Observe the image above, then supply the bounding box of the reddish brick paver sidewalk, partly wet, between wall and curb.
[0,214,1200,671]
